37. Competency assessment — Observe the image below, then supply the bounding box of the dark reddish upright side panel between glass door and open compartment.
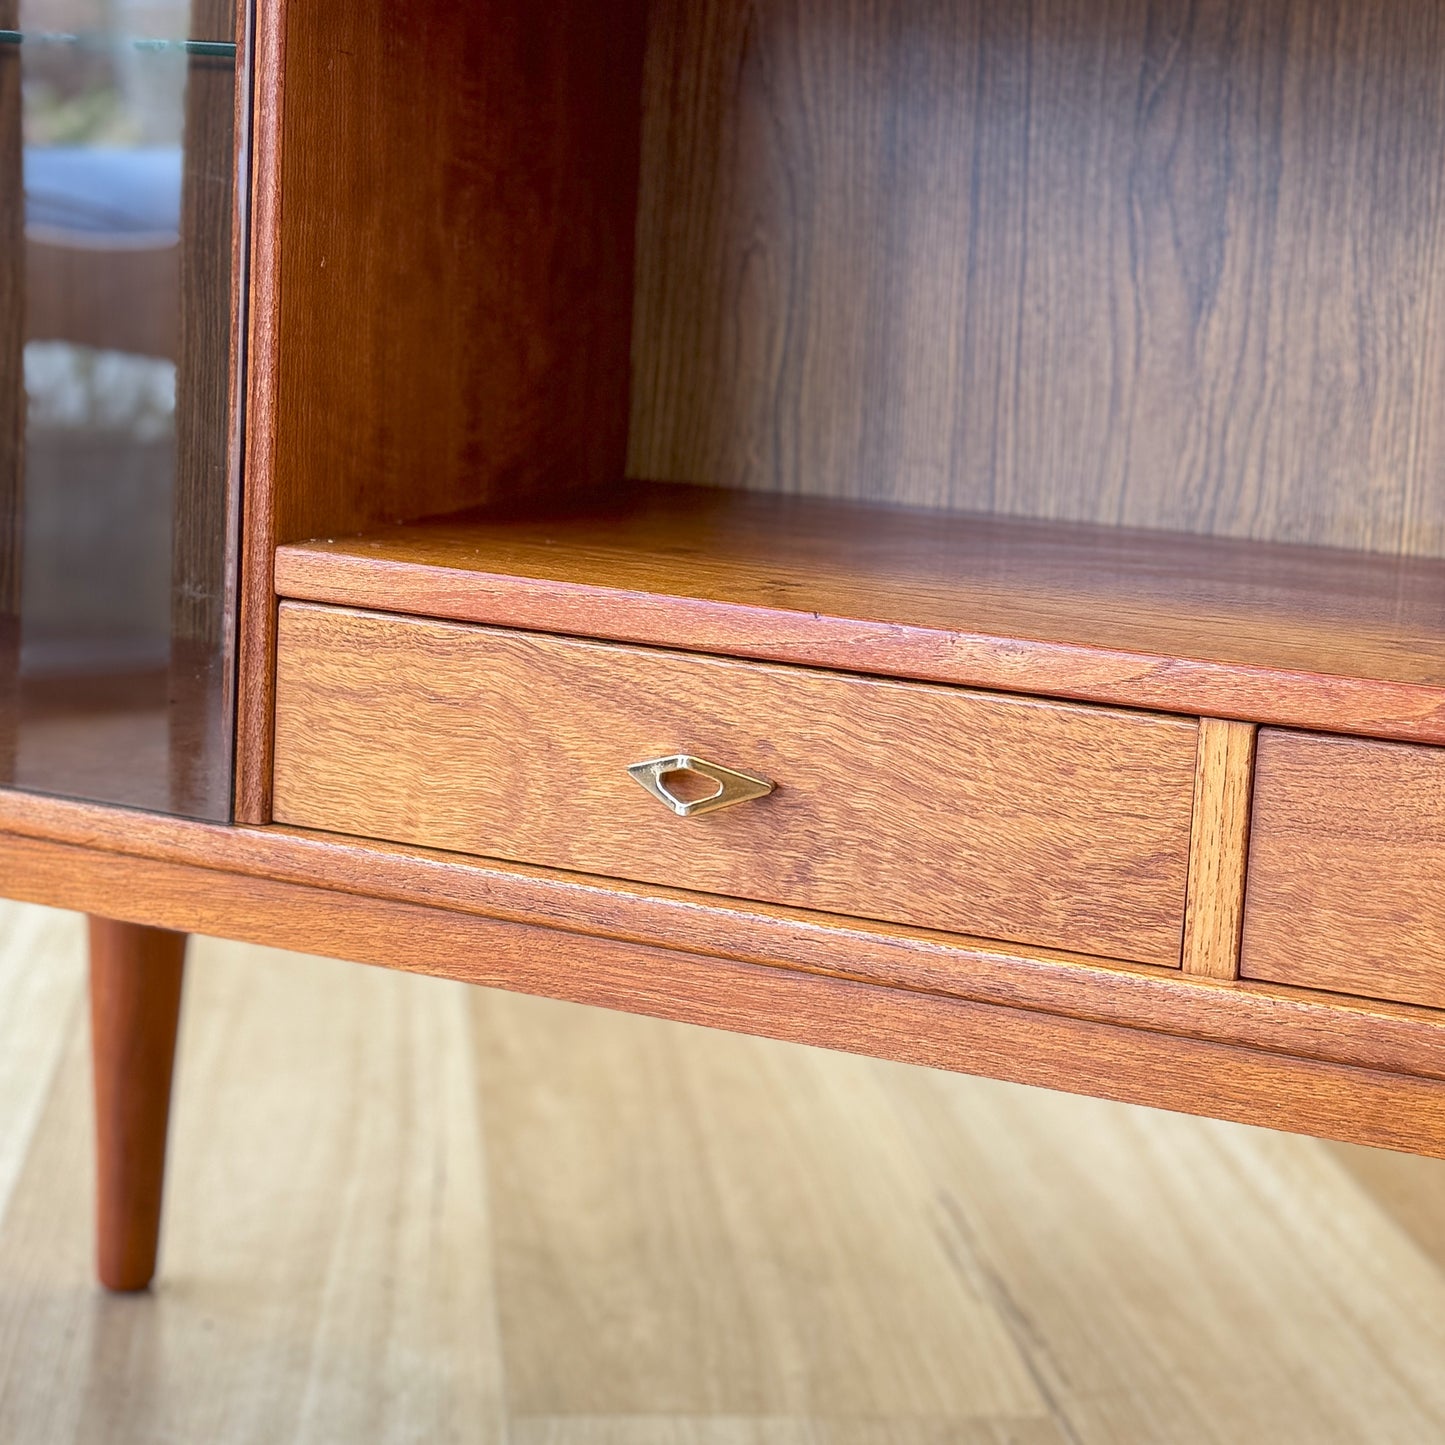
[238,0,644,822]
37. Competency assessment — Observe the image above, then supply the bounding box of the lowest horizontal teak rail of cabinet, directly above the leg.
[0,837,1445,1155]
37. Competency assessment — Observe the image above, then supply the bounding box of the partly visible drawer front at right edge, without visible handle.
[1240,728,1445,1009]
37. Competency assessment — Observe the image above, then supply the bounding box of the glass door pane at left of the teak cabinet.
[0,0,237,819]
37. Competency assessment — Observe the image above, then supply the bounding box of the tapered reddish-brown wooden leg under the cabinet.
[90,918,186,1290]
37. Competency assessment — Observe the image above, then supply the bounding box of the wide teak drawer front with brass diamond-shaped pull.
[275,604,1198,965]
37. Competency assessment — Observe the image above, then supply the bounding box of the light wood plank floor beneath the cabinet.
[0,905,1445,1445]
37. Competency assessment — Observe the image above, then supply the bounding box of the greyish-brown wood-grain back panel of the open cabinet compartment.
[630,0,1445,556]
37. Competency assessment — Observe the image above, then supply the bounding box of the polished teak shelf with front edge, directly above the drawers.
[276,484,1445,743]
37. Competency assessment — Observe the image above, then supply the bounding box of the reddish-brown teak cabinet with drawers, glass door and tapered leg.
[0,0,1445,1287]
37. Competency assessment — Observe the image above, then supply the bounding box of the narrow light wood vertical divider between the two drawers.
[1183,718,1254,978]
